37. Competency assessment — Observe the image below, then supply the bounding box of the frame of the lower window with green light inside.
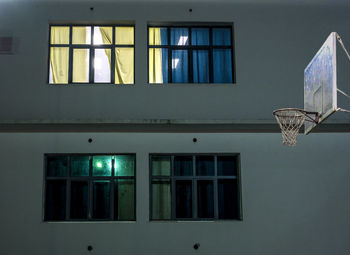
[42,153,137,222]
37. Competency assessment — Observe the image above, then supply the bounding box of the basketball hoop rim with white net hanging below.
[273,108,319,146]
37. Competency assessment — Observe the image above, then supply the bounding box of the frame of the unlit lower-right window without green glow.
[149,153,243,222]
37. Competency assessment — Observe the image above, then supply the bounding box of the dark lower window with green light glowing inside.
[44,154,136,221]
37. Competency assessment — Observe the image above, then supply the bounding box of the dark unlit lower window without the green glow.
[150,154,242,220]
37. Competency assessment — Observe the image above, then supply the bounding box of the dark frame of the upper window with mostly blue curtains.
[147,22,236,85]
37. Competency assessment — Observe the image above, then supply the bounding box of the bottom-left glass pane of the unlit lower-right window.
[152,180,171,220]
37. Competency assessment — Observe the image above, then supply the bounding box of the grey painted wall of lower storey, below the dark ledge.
[0,133,350,255]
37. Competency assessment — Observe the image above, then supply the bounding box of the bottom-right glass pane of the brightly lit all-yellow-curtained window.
[115,48,134,84]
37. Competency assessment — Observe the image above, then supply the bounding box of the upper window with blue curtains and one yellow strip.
[148,24,234,83]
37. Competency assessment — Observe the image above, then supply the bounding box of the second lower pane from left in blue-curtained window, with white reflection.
[171,50,188,83]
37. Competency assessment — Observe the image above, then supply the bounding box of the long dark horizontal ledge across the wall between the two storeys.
[0,123,350,133]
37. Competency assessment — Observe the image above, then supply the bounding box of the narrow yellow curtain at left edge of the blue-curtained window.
[148,28,163,83]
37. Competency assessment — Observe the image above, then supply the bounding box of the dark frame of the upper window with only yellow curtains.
[47,23,136,86]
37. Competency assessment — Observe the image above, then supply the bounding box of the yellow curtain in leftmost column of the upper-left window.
[50,27,69,84]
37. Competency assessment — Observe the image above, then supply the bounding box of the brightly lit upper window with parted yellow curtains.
[49,25,134,84]
